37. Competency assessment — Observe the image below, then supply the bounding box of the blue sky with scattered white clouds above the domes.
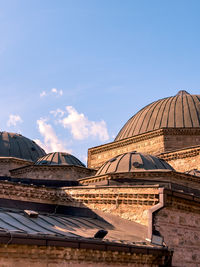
[0,0,200,161]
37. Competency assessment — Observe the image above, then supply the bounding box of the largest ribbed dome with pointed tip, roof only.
[115,91,200,141]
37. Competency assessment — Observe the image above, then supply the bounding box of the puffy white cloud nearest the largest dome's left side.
[59,106,109,141]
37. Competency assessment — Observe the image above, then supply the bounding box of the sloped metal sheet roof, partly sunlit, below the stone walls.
[0,208,147,244]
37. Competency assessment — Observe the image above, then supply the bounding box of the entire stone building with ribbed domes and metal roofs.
[0,91,200,267]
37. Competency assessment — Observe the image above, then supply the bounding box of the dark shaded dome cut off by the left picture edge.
[0,132,46,161]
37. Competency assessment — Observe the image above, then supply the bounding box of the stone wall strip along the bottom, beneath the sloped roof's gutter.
[0,245,168,267]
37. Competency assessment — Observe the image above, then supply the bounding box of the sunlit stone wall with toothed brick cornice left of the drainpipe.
[65,187,158,226]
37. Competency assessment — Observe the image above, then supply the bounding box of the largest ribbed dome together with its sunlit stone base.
[88,91,200,169]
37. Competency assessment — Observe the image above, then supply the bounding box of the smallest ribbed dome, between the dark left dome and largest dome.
[35,152,85,167]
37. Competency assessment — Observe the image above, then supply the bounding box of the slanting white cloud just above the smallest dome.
[34,118,71,153]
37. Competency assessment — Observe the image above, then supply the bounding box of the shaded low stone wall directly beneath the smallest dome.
[10,166,96,181]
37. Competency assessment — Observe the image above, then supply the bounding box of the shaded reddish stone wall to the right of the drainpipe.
[154,198,200,267]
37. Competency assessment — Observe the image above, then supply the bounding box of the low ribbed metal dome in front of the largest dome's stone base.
[96,151,173,175]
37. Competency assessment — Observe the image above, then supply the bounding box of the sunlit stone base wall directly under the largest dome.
[88,128,200,169]
